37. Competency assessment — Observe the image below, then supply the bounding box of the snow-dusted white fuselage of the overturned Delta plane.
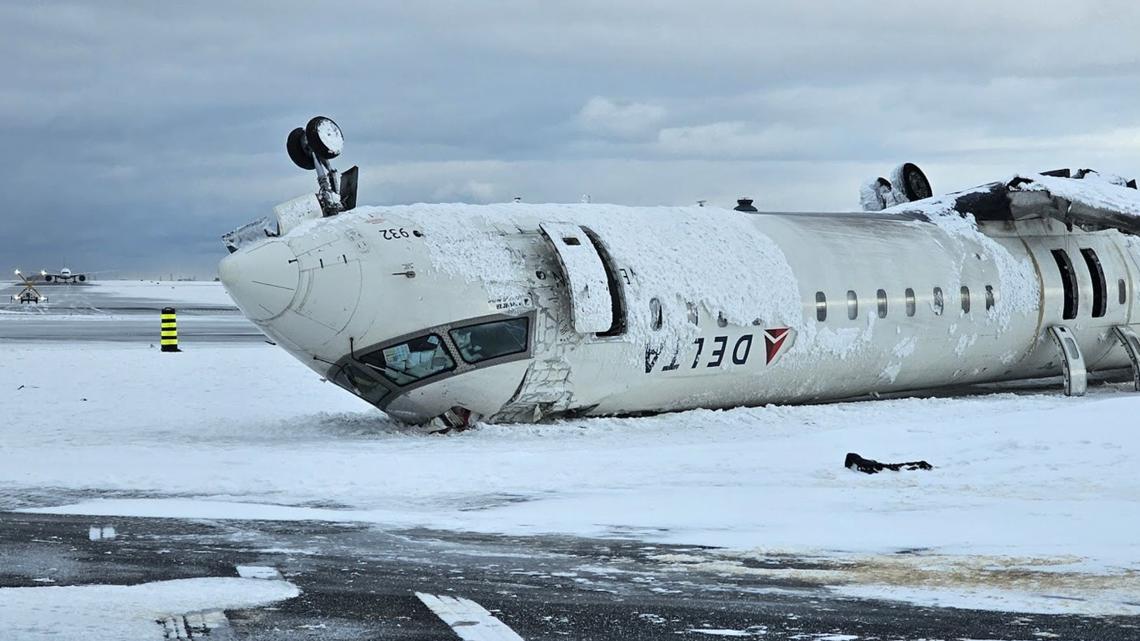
[220,197,1137,422]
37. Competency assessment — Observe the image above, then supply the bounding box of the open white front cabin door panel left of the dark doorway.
[539,222,618,334]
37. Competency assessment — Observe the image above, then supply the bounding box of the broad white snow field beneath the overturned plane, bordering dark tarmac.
[0,343,1140,614]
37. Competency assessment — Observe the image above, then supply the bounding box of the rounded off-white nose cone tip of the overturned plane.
[218,241,299,321]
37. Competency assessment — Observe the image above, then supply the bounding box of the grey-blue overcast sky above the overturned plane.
[0,0,1140,277]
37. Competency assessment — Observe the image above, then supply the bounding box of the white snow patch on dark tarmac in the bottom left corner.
[0,578,301,641]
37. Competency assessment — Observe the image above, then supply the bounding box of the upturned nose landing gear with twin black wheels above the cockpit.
[285,115,359,218]
